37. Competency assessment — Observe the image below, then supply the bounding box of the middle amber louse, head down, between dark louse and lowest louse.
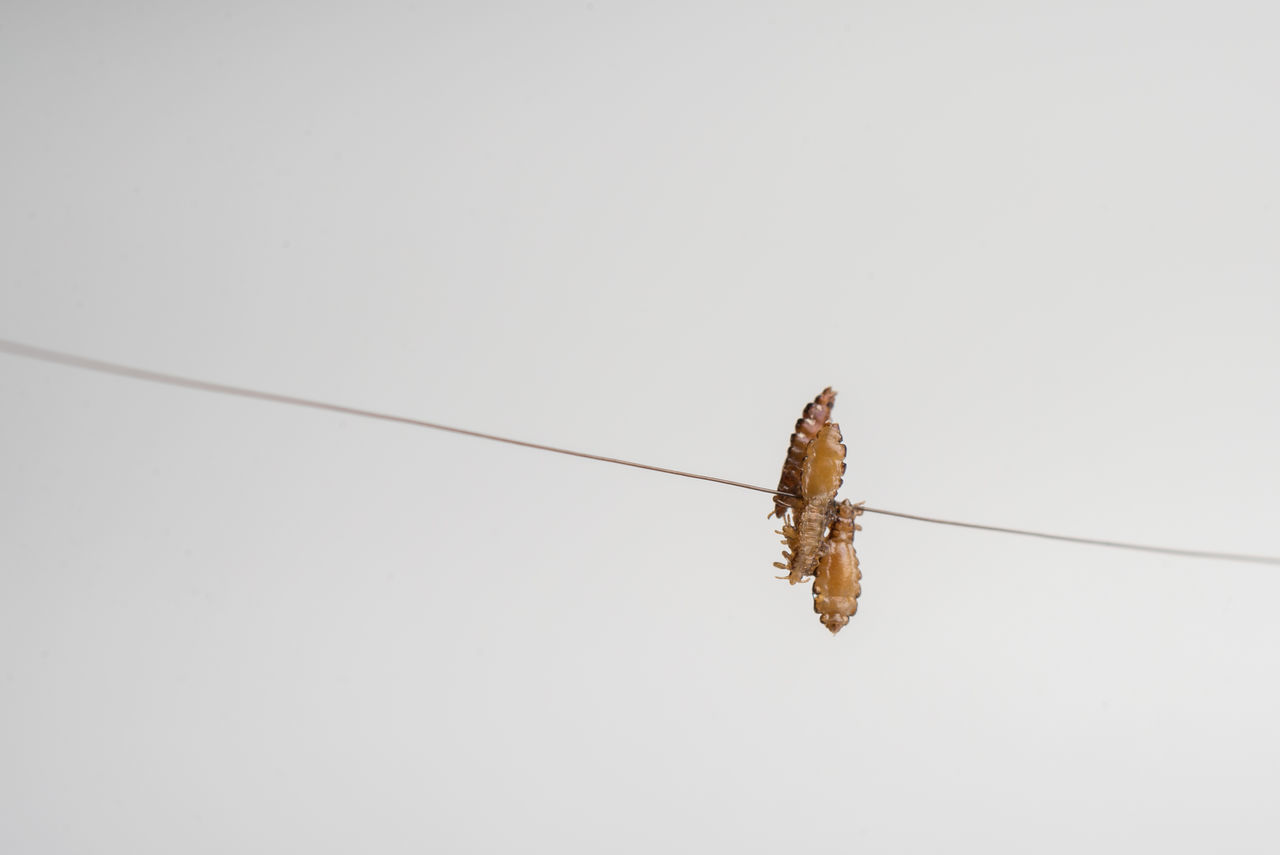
[773,421,845,585]
